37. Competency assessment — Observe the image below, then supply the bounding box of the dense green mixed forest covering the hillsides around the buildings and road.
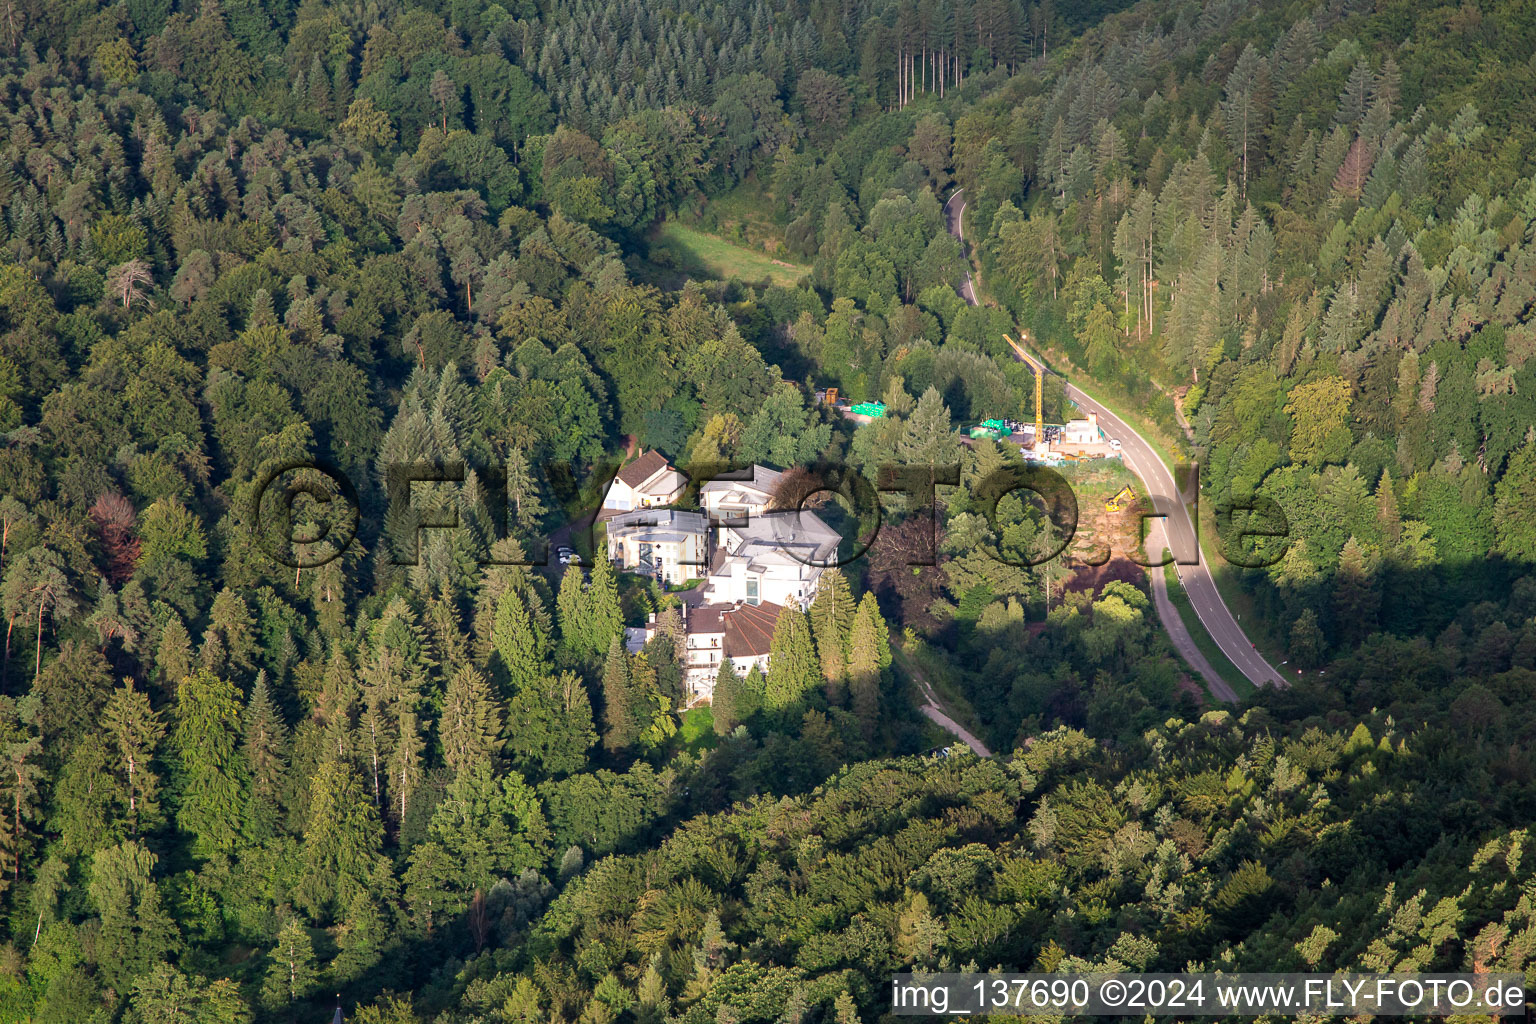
[0,0,1536,1024]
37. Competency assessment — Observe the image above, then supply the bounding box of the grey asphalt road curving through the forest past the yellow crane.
[945,189,1286,700]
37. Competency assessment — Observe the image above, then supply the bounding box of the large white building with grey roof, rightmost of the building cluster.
[703,511,842,608]
